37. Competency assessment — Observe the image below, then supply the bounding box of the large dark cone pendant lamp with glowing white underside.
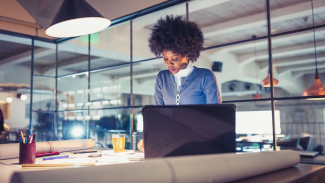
[45,0,111,37]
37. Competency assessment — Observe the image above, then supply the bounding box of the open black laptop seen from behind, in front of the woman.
[142,104,236,158]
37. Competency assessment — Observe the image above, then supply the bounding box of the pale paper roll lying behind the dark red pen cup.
[0,139,95,159]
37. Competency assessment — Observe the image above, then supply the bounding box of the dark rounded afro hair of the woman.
[149,15,204,62]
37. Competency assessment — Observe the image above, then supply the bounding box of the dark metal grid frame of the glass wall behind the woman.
[19,0,325,146]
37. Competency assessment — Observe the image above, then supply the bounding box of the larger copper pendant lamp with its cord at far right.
[302,0,325,100]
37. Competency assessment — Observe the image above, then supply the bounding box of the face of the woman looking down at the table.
[162,50,188,74]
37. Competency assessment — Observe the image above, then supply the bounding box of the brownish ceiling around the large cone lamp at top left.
[0,0,166,39]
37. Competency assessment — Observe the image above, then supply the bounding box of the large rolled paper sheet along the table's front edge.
[11,150,300,183]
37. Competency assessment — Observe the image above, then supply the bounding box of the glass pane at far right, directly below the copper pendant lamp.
[275,100,325,151]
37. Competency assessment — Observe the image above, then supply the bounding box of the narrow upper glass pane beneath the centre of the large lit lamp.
[58,35,88,76]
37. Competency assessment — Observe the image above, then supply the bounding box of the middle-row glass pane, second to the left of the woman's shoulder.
[89,65,131,109]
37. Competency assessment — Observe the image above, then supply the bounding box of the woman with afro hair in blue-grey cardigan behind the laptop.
[138,15,221,151]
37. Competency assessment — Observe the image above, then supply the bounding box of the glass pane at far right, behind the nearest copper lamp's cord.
[270,29,325,97]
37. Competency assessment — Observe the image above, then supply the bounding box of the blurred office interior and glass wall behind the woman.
[0,0,325,151]
